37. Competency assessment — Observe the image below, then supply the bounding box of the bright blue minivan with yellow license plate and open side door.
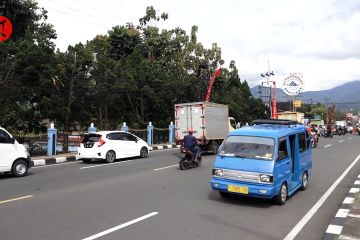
[211,120,312,205]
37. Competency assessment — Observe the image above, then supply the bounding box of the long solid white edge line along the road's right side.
[284,154,360,240]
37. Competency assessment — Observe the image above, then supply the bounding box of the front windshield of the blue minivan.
[219,136,275,160]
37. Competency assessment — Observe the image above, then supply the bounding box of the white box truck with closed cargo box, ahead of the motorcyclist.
[175,102,236,153]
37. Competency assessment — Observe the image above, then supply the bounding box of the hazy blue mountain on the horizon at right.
[251,80,360,109]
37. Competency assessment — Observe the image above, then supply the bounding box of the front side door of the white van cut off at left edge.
[0,129,17,172]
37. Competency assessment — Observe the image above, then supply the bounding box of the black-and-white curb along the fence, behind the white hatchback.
[32,144,180,167]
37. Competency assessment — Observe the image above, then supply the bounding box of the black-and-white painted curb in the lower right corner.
[323,175,360,240]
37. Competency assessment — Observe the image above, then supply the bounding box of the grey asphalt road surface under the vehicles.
[0,134,360,240]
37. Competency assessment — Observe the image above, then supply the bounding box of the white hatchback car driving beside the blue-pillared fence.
[78,131,149,163]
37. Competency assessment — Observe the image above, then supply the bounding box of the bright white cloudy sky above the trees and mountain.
[37,0,360,91]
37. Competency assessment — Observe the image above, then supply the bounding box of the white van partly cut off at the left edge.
[0,127,33,177]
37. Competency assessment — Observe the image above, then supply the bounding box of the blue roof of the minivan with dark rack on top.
[230,124,306,138]
